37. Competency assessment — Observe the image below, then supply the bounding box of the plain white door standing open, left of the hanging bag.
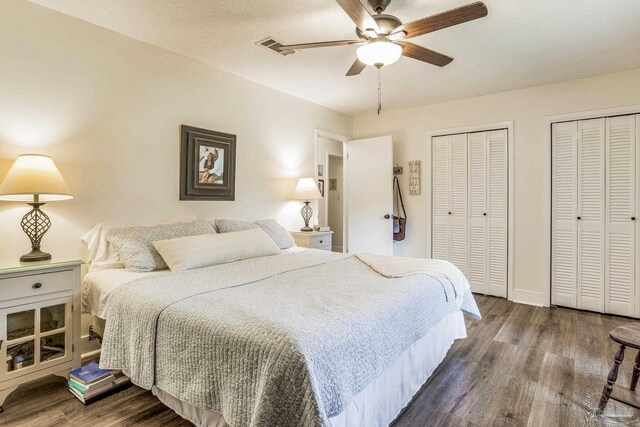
[347,136,393,255]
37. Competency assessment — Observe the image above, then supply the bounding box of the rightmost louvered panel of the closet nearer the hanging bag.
[487,129,508,297]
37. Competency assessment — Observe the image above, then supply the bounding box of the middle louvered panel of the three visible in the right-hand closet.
[578,119,605,312]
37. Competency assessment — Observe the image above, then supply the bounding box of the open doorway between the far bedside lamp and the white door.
[316,131,348,252]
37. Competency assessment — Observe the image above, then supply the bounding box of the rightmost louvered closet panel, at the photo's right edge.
[605,116,640,316]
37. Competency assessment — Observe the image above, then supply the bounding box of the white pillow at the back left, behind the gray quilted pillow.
[81,216,196,271]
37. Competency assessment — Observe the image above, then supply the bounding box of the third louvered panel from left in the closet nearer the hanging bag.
[467,132,489,294]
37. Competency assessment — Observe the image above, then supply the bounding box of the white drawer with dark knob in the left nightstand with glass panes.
[0,270,74,300]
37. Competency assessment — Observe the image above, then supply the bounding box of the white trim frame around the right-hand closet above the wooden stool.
[542,104,640,317]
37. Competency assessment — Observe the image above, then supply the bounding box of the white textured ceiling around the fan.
[31,0,640,116]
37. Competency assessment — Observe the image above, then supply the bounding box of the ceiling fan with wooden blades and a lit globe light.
[280,0,488,76]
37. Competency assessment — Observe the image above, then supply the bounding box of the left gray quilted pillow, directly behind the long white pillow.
[107,221,216,271]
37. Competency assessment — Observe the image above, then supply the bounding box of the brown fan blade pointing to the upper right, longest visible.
[393,1,489,38]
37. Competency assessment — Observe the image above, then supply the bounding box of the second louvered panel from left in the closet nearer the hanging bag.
[449,134,469,276]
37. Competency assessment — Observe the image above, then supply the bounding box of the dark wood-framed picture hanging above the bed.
[180,125,236,200]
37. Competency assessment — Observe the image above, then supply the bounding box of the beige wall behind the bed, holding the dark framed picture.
[0,0,352,260]
